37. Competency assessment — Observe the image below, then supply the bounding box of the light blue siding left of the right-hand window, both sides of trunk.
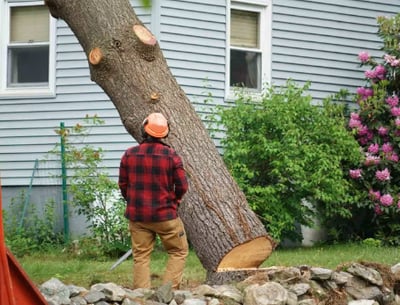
[0,0,226,186]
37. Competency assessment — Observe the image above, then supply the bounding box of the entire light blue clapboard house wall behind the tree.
[0,0,400,235]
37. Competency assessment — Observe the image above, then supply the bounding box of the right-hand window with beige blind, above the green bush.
[229,0,271,91]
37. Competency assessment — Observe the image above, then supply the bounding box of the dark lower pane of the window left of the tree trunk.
[8,46,49,85]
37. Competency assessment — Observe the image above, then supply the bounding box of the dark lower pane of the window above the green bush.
[230,50,261,89]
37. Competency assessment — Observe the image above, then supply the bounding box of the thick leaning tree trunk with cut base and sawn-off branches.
[45,0,274,277]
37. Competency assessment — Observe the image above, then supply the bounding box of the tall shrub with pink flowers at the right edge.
[348,14,400,245]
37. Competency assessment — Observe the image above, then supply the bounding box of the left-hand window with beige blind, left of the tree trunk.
[0,1,54,97]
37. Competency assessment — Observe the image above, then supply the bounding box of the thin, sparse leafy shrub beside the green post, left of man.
[52,116,130,255]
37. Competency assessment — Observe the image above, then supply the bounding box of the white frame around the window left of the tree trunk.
[0,0,56,99]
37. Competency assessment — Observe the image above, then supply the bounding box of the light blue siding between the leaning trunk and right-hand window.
[158,0,227,104]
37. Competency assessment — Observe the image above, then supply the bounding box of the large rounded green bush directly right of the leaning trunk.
[216,81,360,240]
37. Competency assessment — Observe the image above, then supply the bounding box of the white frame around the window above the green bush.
[225,0,272,100]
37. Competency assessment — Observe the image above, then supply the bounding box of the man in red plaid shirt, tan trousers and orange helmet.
[118,113,188,289]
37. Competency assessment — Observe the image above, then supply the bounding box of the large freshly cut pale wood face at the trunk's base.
[217,236,274,272]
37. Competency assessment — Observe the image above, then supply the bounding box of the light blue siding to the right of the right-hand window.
[272,0,400,100]
